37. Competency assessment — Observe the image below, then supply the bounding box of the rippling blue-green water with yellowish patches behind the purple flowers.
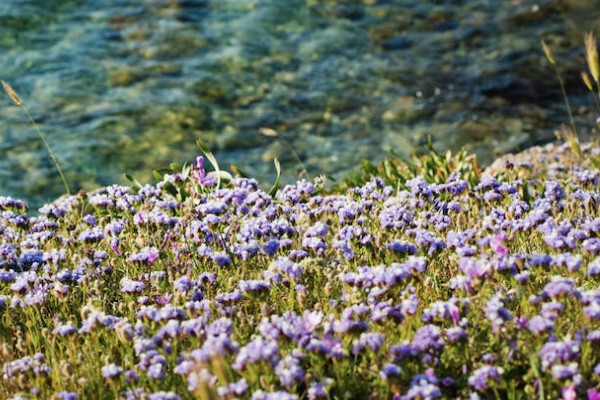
[0,0,600,207]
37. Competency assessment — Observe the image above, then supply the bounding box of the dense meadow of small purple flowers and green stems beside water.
[0,142,600,400]
